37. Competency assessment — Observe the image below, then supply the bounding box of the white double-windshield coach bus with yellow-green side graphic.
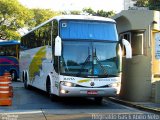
[20,15,132,102]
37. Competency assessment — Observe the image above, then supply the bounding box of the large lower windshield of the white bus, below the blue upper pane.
[60,40,120,77]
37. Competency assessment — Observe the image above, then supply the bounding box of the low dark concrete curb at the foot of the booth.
[108,97,160,114]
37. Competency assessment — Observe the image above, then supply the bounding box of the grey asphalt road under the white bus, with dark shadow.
[0,82,160,120]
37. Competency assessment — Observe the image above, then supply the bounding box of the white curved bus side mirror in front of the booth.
[122,39,132,58]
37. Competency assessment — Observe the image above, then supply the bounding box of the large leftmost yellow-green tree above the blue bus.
[0,0,33,39]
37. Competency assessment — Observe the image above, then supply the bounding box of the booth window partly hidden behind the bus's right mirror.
[120,31,144,56]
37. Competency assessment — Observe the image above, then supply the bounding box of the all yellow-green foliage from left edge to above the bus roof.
[0,0,58,39]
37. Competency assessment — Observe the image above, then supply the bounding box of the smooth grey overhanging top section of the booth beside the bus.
[113,10,155,33]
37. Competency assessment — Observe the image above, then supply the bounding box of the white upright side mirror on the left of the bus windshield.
[54,36,62,56]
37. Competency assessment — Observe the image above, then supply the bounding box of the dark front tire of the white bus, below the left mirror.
[46,77,57,101]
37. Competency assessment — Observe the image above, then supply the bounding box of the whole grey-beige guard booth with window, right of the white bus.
[113,10,160,103]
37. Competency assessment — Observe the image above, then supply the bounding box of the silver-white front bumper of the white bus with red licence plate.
[59,86,117,97]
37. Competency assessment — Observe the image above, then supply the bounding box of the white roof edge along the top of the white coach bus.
[23,15,116,36]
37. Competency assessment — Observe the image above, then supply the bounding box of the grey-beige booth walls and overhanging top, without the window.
[113,10,160,101]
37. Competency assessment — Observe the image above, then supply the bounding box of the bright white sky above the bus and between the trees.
[19,0,124,13]
